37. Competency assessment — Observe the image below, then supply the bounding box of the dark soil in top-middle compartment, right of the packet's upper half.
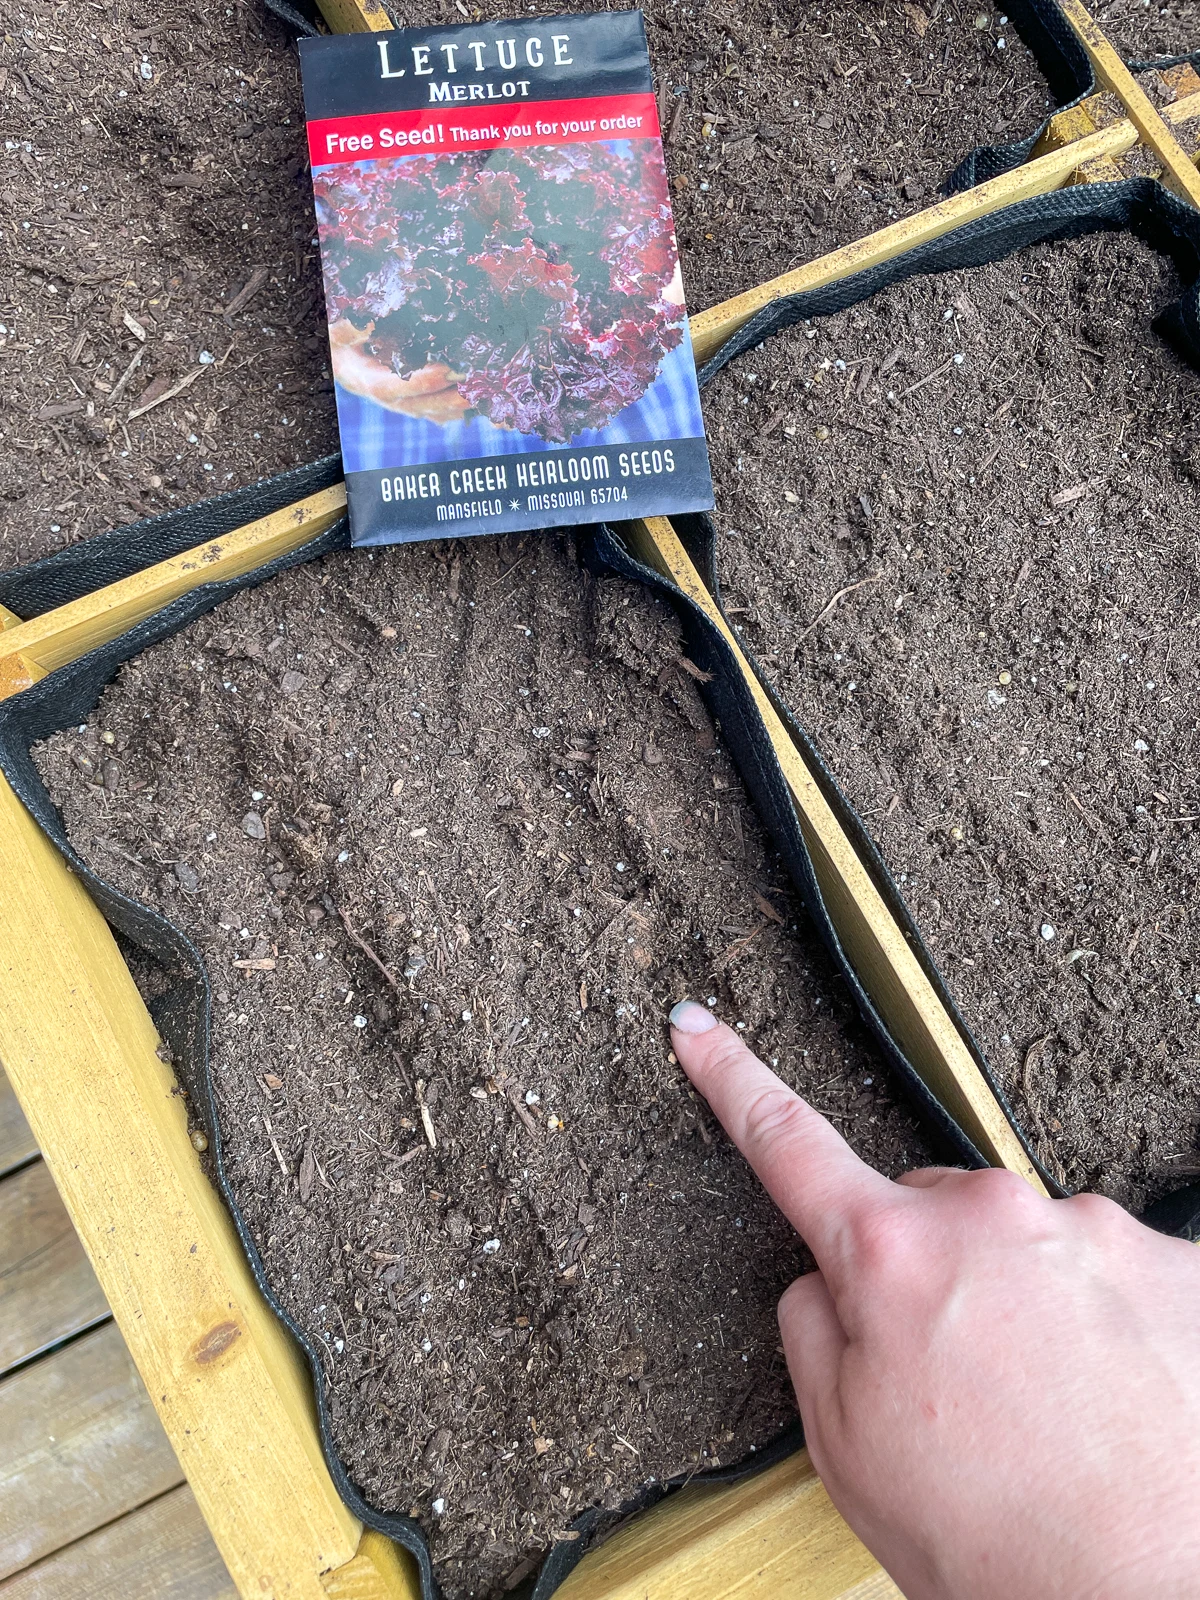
[387,0,1051,312]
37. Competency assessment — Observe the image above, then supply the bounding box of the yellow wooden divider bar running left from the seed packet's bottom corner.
[0,483,346,678]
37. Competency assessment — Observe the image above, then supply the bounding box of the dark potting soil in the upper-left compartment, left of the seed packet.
[0,0,338,568]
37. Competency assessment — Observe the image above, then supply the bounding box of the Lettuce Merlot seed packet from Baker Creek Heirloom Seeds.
[301,11,712,544]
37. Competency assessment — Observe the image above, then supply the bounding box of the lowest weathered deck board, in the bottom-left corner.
[0,1485,236,1600]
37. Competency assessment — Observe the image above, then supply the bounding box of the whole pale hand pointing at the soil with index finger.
[670,1002,1200,1600]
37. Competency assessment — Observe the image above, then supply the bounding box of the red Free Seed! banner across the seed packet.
[300,92,659,166]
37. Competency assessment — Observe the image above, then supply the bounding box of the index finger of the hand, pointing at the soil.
[670,1000,893,1272]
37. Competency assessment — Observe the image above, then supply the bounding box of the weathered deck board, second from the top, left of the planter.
[0,1164,109,1374]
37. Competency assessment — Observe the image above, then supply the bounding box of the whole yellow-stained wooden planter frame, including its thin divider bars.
[0,0,1200,1600]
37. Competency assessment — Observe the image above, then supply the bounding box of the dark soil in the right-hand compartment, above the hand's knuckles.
[706,237,1200,1208]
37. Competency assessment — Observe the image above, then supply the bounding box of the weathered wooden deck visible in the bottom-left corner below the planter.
[0,1070,237,1600]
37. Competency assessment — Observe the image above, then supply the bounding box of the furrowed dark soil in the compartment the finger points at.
[38,534,928,1595]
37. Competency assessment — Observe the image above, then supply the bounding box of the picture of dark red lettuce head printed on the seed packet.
[314,139,685,443]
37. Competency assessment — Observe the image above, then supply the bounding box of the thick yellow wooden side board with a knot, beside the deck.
[0,779,414,1600]
